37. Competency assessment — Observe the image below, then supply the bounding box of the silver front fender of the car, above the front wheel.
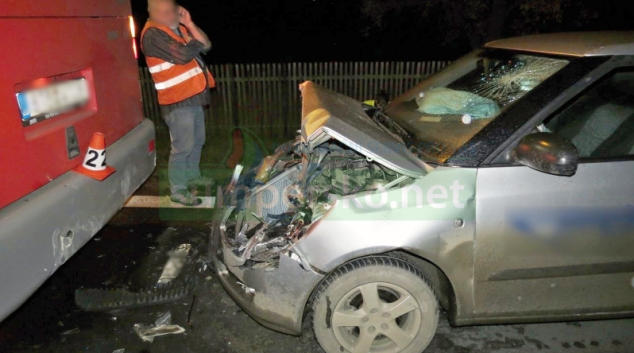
[296,167,476,322]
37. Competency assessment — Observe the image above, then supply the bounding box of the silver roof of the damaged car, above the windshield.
[485,32,634,56]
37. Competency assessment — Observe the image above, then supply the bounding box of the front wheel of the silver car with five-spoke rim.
[312,256,439,353]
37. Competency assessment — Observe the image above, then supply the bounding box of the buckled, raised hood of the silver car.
[300,81,431,178]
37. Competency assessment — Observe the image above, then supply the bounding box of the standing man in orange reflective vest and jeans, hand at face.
[141,0,216,206]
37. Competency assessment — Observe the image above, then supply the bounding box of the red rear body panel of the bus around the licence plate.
[0,17,143,208]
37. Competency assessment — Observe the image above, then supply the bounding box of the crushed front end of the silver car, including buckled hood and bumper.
[210,82,429,334]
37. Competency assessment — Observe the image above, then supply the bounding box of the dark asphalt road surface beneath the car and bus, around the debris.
[0,175,634,353]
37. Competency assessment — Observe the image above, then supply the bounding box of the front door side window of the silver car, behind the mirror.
[538,71,634,159]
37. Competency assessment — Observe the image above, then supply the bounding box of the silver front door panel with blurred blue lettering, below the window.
[474,161,634,322]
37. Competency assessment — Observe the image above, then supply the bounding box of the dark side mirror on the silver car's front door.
[514,132,579,176]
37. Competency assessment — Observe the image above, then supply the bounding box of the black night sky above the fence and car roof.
[132,0,634,63]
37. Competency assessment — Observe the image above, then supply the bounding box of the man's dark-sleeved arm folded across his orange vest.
[143,28,203,65]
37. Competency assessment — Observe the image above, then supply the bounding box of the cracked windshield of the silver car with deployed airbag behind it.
[386,53,568,163]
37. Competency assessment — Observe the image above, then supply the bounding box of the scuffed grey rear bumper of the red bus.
[0,119,156,320]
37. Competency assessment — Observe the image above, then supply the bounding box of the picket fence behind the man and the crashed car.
[139,61,449,137]
